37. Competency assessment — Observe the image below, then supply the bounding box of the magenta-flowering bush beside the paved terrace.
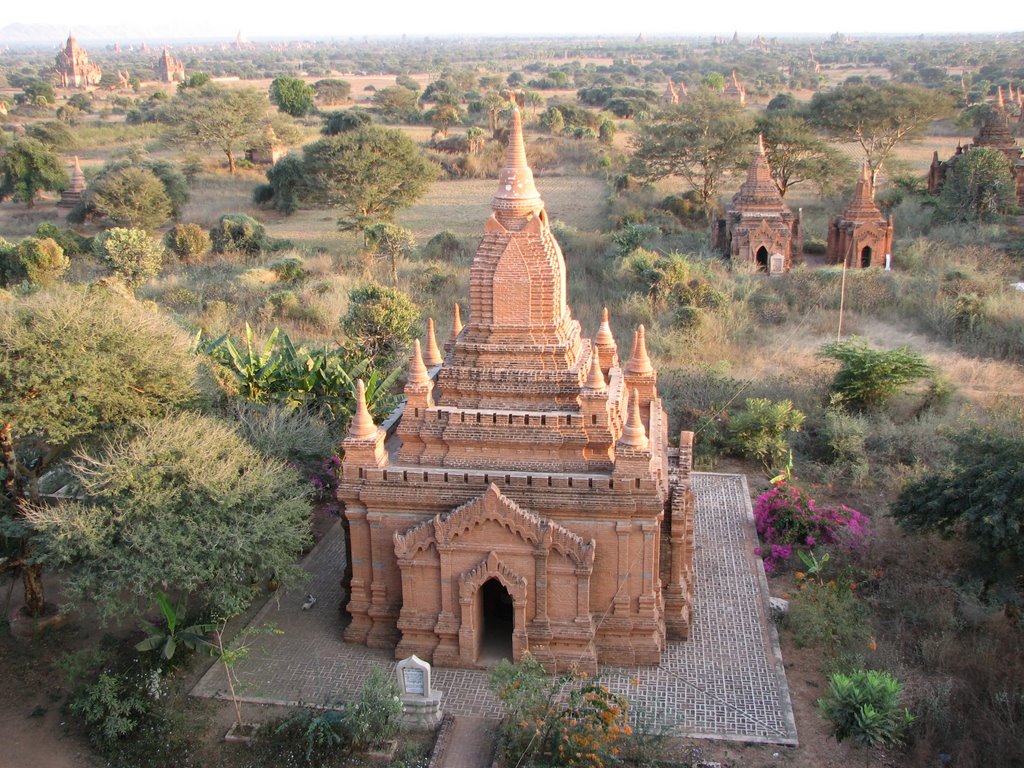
[754,480,867,573]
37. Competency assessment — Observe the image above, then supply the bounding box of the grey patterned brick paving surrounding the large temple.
[193,473,797,744]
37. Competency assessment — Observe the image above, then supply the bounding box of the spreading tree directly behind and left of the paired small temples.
[633,88,751,210]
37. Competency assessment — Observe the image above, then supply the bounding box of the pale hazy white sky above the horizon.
[6,0,1024,39]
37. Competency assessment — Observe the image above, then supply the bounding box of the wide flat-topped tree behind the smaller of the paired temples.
[809,83,952,187]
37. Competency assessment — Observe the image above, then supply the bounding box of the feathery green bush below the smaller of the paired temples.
[818,339,934,410]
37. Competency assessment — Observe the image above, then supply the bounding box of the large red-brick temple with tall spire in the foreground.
[338,110,693,672]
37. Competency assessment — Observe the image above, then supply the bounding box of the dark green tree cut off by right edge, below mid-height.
[891,430,1024,586]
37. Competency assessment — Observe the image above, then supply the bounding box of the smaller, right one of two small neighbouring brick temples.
[825,163,893,267]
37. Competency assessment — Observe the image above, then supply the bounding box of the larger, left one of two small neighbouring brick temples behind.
[711,136,804,274]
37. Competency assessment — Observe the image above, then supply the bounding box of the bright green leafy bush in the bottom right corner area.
[818,670,913,749]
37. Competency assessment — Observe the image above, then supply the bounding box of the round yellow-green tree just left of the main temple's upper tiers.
[341,285,420,370]
